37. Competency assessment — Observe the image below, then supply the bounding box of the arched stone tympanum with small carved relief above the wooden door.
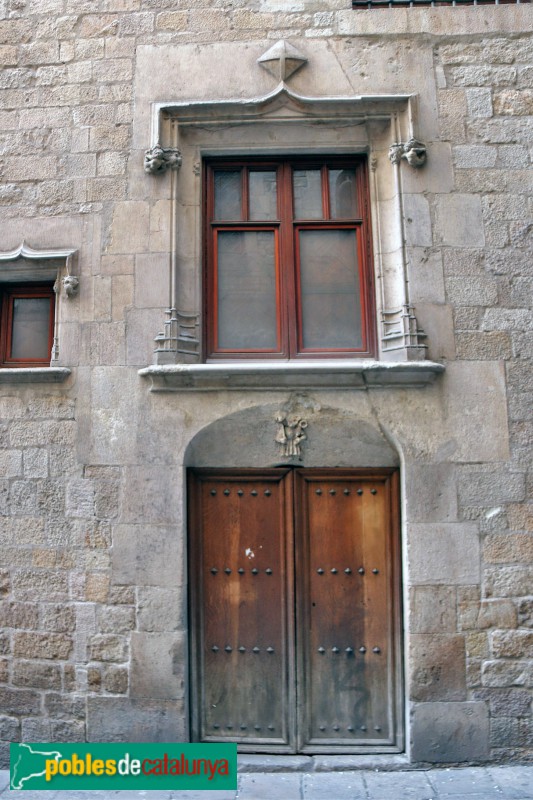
[185,394,400,468]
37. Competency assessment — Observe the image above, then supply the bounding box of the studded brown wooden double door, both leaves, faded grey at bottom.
[189,468,403,753]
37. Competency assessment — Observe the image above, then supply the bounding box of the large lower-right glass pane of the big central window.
[299,230,362,350]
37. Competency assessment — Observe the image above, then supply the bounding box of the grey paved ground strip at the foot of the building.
[0,766,533,800]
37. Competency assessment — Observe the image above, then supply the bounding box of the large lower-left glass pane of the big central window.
[217,231,278,350]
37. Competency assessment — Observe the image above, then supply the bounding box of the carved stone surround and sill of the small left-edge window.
[0,242,78,384]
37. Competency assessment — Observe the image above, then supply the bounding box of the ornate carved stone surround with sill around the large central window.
[139,82,444,391]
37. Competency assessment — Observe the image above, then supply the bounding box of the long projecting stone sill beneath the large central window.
[139,360,444,392]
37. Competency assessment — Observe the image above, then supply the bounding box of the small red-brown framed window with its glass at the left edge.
[0,283,55,367]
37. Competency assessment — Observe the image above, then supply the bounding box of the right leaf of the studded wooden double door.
[295,470,401,752]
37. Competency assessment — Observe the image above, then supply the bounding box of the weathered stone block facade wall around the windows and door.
[0,0,533,764]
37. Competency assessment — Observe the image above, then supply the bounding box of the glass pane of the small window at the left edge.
[10,297,50,360]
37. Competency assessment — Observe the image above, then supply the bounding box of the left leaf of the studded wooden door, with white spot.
[189,470,295,753]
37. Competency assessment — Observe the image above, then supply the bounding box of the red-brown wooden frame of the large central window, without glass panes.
[203,156,376,360]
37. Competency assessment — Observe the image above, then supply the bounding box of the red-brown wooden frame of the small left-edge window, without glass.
[0,283,55,368]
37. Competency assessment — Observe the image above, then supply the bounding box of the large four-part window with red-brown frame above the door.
[204,158,375,359]
